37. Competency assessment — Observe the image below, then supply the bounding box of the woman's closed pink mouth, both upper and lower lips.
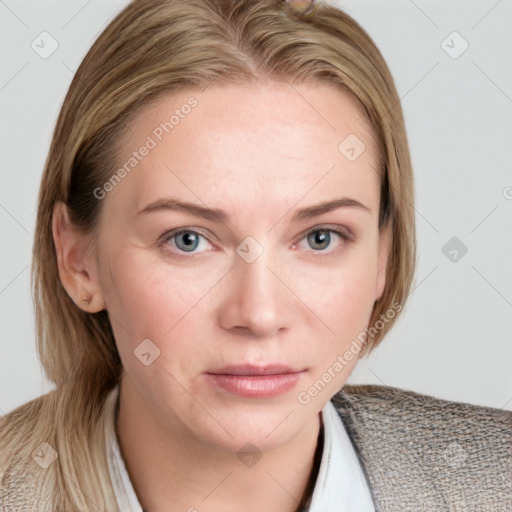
[205,364,306,398]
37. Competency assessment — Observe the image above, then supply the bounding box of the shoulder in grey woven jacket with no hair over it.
[332,385,512,511]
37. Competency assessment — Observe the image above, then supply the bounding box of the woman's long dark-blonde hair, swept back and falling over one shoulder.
[1,0,416,511]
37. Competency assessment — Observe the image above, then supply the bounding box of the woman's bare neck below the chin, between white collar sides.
[116,379,322,512]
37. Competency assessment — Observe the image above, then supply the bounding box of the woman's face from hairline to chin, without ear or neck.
[95,83,387,449]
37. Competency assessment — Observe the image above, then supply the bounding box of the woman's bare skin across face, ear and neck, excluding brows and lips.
[54,82,389,512]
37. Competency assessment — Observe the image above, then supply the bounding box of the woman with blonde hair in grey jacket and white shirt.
[0,0,512,512]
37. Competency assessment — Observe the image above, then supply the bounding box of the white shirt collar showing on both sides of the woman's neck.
[105,386,375,512]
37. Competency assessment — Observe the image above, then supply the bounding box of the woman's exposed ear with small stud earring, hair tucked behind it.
[52,201,105,313]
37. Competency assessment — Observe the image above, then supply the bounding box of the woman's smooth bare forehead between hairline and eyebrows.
[109,82,380,221]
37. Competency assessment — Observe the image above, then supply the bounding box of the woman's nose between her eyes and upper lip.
[219,245,294,338]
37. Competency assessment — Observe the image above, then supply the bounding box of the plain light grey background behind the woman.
[0,0,512,413]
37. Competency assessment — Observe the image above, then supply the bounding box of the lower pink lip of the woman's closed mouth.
[206,372,302,398]
